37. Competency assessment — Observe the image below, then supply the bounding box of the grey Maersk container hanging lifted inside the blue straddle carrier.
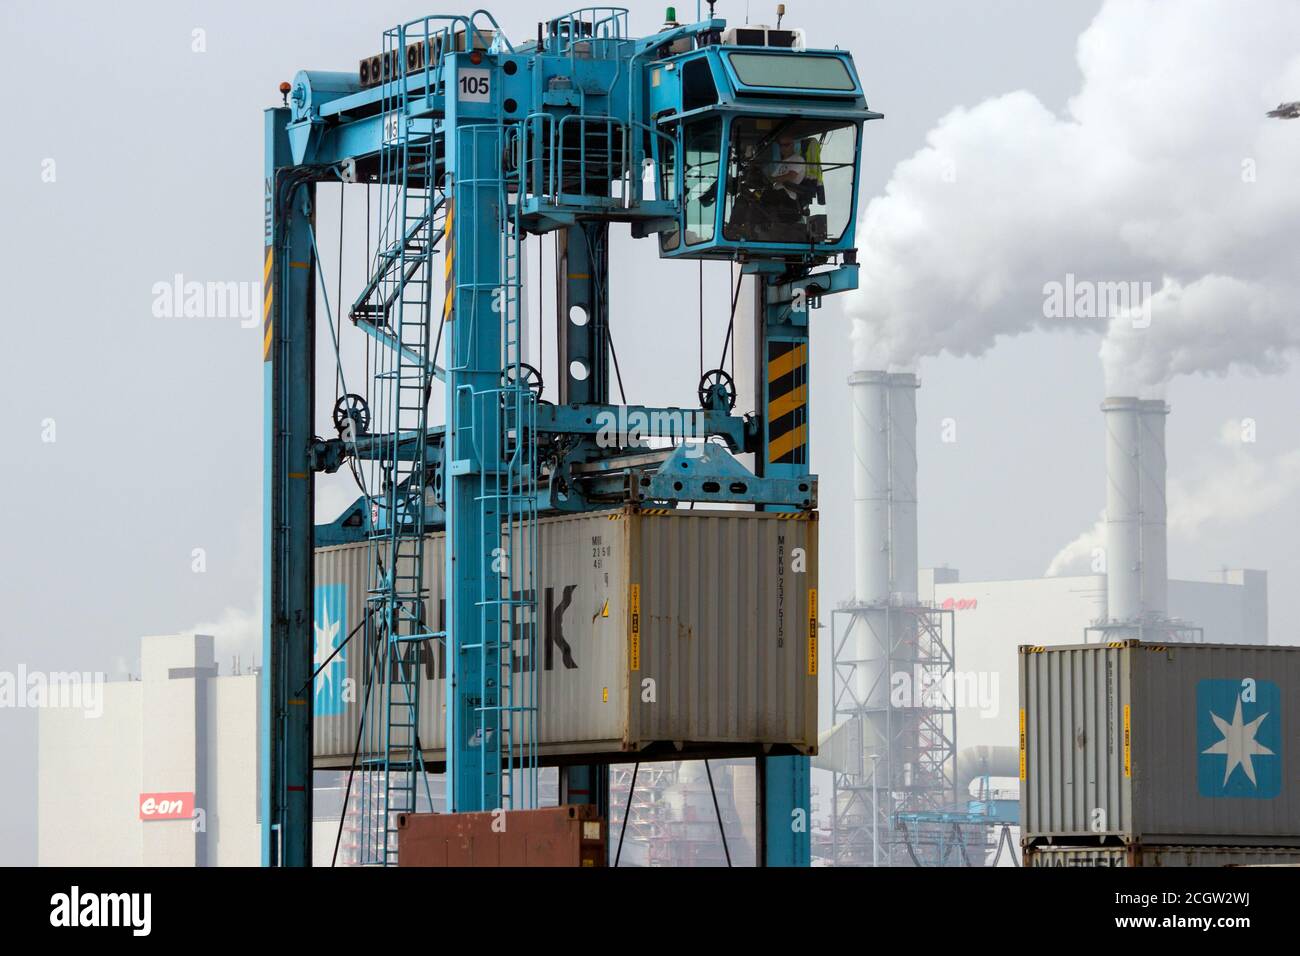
[313,509,818,767]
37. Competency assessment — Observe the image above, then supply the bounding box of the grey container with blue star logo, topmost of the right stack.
[1019,641,1300,847]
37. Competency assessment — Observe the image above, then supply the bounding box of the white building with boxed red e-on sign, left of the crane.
[36,635,334,866]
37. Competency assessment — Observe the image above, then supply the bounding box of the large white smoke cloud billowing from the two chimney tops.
[846,0,1300,394]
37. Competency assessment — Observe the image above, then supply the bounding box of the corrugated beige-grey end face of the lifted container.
[627,510,818,749]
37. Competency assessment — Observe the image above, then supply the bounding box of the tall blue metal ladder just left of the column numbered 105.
[354,18,442,865]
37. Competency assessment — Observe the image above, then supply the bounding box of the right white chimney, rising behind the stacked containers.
[1101,397,1169,623]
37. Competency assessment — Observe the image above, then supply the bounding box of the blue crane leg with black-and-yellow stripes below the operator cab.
[754,274,813,866]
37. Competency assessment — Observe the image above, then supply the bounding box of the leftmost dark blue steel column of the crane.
[261,108,316,866]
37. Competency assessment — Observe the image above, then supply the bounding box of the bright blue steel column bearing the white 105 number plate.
[443,55,506,813]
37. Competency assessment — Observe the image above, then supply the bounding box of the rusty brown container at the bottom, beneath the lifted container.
[398,805,607,866]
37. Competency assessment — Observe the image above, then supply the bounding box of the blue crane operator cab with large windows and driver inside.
[647,36,881,259]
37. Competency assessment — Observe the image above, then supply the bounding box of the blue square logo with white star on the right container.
[1196,678,1282,800]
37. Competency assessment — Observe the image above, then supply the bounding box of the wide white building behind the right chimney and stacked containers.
[919,568,1269,749]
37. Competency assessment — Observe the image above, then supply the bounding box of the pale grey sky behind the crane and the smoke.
[0,0,1300,862]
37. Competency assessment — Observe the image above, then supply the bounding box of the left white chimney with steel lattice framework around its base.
[833,371,954,865]
